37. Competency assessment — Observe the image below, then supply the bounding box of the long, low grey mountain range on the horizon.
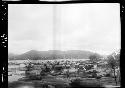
[8,50,101,60]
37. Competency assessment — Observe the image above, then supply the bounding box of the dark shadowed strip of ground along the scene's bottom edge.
[8,76,120,88]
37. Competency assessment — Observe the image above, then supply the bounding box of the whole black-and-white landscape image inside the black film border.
[8,3,121,88]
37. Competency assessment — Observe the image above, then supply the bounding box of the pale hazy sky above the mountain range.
[8,3,121,54]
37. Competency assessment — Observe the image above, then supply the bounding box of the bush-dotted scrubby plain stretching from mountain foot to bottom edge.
[8,60,120,88]
